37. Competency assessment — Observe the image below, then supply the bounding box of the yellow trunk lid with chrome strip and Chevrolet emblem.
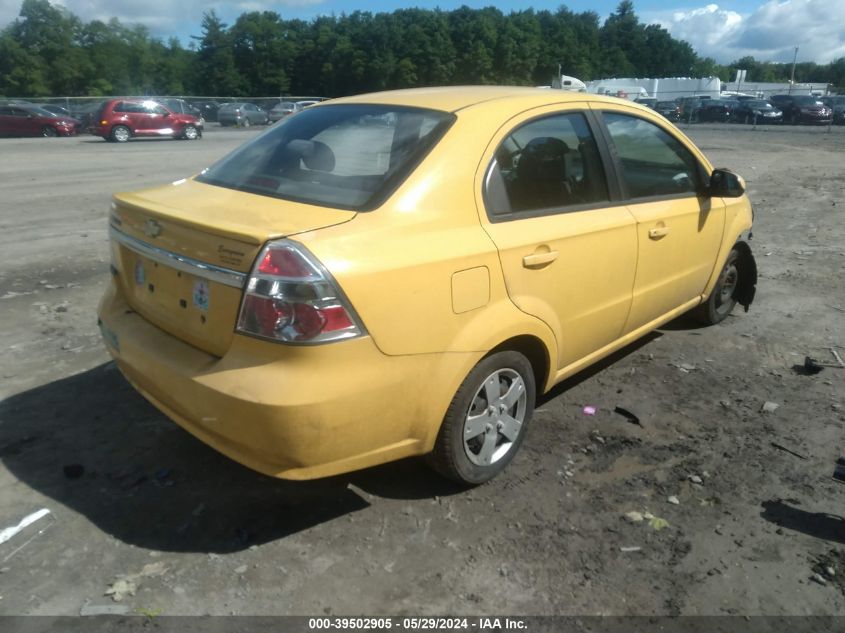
[109,180,356,356]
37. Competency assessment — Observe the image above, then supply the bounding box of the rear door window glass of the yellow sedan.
[485,113,609,216]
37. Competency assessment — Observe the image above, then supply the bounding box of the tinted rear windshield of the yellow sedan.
[197,104,455,211]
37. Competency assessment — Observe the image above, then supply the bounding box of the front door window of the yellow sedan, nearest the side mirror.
[603,112,701,198]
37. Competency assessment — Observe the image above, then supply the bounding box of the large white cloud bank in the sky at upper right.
[643,0,845,63]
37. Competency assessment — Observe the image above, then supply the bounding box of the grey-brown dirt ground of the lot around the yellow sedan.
[0,125,845,615]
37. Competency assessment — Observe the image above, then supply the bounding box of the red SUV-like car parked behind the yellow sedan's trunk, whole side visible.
[94,99,202,143]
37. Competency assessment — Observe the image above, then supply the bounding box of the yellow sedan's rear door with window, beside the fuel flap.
[478,106,637,371]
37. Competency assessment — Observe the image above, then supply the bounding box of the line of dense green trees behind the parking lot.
[0,0,845,97]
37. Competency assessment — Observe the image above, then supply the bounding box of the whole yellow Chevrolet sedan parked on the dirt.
[99,86,757,484]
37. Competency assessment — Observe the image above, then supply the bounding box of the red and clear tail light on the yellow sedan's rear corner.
[237,240,365,344]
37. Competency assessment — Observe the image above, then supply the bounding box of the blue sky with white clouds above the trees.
[0,0,845,63]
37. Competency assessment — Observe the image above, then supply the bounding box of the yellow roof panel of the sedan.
[329,86,628,112]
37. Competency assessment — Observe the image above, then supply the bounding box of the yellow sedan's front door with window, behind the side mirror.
[599,106,725,332]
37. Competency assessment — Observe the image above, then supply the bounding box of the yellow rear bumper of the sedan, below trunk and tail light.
[99,279,481,479]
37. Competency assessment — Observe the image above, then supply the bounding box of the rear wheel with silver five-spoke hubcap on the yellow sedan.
[428,351,536,485]
